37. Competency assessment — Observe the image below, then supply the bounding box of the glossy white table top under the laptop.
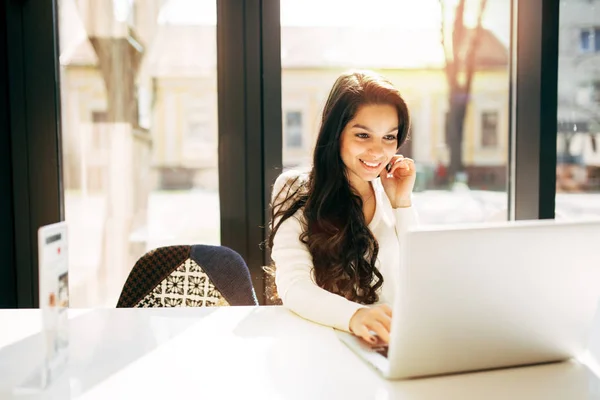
[0,307,600,400]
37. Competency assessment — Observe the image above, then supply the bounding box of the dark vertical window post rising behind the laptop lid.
[508,0,560,220]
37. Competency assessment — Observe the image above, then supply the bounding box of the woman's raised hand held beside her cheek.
[380,155,417,208]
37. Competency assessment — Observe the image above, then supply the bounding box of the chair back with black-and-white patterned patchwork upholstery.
[117,245,258,308]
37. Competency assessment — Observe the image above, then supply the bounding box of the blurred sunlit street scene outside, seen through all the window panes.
[58,0,600,307]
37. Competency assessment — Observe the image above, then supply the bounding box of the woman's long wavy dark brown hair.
[268,71,410,304]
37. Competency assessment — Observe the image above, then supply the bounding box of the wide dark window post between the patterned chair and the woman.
[217,0,282,304]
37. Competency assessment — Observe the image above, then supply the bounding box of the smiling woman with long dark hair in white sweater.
[269,71,416,343]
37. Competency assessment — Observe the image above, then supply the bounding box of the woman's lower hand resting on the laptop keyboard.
[350,304,392,344]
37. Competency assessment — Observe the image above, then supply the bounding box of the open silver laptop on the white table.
[336,220,600,379]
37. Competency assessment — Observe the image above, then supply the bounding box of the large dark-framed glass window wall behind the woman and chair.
[0,0,568,307]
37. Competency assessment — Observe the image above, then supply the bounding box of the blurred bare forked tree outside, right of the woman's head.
[439,0,487,179]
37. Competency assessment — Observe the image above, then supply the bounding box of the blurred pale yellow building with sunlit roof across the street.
[63,24,509,193]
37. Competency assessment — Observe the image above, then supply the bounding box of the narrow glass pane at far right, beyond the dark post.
[555,0,600,219]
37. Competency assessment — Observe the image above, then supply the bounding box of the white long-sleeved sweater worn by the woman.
[271,171,417,331]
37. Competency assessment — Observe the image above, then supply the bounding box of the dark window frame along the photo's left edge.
[0,0,64,308]
